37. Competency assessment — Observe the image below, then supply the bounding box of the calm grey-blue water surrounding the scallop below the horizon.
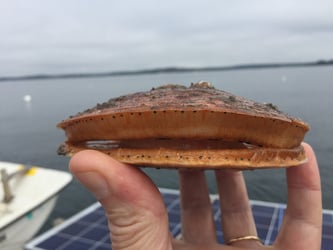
[0,66,333,230]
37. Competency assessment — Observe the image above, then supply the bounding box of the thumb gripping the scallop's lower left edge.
[69,150,171,249]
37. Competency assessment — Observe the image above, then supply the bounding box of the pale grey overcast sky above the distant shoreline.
[0,0,333,76]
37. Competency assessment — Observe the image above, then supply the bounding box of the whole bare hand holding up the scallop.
[70,143,322,250]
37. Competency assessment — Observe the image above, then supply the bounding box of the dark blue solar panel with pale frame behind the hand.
[25,189,333,250]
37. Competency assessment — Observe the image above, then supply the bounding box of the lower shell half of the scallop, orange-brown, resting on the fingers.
[58,139,307,169]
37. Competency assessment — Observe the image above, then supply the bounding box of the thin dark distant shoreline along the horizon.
[0,59,333,82]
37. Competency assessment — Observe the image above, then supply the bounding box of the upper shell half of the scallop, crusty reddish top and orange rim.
[58,82,309,148]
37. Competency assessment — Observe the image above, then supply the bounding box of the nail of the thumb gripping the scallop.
[76,172,109,200]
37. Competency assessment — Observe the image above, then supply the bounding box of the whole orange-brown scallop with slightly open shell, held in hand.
[57,82,309,169]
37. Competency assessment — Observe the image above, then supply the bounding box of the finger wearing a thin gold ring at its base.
[215,170,261,247]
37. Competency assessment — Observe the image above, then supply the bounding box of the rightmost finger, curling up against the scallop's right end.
[276,143,322,249]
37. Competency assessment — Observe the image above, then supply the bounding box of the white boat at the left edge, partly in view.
[0,161,72,250]
